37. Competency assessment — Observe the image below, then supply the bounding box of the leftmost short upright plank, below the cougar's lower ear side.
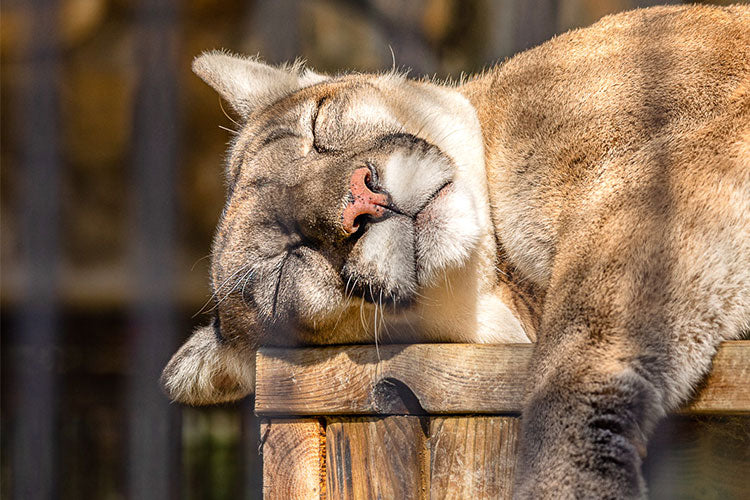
[260,418,326,500]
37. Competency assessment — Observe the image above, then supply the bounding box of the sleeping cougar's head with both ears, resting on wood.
[163,52,524,403]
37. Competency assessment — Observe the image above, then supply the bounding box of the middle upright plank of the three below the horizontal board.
[326,417,429,500]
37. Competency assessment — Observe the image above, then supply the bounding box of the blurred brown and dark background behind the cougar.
[0,0,750,499]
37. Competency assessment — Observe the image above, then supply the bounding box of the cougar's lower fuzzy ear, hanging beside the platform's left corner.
[161,325,255,405]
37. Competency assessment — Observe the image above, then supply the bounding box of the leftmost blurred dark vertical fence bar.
[11,0,61,500]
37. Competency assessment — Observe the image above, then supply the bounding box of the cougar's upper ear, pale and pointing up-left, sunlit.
[193,51,328,120]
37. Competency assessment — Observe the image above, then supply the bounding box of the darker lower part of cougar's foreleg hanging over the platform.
[514,369,663,500]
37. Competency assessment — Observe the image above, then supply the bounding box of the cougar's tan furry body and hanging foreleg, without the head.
[460,6,750,498]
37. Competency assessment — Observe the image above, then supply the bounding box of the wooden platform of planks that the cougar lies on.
[255,341,750,499]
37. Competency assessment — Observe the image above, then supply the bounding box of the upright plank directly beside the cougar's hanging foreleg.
[430,416,520,500]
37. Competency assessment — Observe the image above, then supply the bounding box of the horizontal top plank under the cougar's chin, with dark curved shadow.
[255,341,750,415]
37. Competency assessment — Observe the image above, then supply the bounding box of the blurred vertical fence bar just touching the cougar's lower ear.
[127,0,181,500]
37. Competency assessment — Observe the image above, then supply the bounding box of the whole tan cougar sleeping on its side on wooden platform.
[163,6,750,498]
